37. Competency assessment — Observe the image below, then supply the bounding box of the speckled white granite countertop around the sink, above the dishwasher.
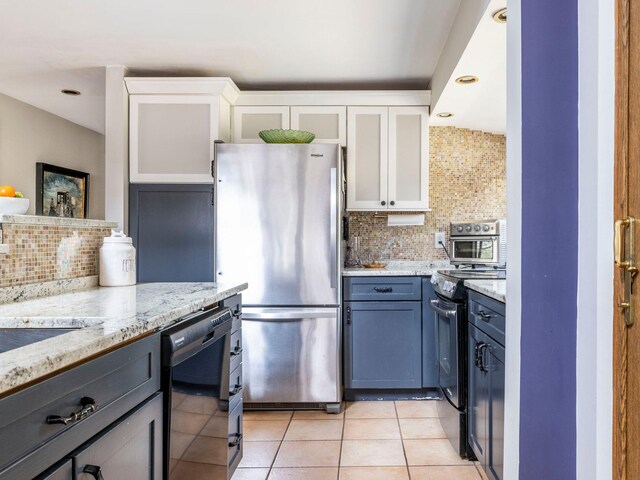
[0,283,247,395]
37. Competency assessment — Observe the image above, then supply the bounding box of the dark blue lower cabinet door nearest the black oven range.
[467,325,490,466]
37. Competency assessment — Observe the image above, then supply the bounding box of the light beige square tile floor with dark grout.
[232,400,486,480]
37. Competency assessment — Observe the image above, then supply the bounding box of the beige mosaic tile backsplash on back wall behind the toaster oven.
[349,127,507,260]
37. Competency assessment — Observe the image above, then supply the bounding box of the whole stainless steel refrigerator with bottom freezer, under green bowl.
[213,144,343,411]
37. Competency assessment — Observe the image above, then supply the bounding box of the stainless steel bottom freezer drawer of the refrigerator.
[242,307,341,403]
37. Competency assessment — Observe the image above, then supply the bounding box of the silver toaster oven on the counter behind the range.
[449,220,507,267]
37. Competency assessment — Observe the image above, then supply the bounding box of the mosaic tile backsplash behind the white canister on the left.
[0,223,111,287]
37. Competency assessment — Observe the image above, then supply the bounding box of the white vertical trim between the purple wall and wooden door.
[576,0,615,480]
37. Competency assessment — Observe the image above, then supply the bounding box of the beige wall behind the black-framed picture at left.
[0,94,105,219]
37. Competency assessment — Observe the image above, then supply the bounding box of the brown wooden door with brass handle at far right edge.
[613,0,640,480]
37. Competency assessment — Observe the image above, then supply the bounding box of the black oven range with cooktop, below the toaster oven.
[430,269,505,457]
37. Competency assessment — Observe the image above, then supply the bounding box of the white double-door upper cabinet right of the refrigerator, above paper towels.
[347,107,429,211]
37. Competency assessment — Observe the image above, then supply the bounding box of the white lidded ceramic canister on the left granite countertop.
[100,230,136,287]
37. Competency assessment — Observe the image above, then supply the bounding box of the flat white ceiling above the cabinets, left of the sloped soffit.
[0,0,460,132]
